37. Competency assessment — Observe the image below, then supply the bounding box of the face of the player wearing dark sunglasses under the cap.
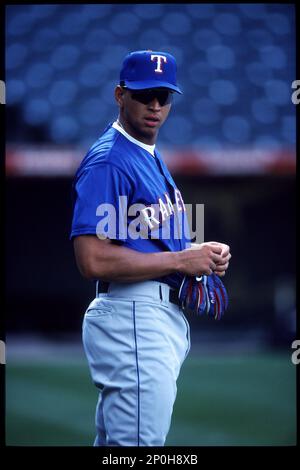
[115,86,172,145]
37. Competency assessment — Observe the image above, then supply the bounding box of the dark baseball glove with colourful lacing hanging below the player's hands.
[178,273,228,320]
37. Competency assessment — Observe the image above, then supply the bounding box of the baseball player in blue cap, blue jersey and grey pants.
[71,51,231,446]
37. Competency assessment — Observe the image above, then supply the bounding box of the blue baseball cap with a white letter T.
[120,51,182,94]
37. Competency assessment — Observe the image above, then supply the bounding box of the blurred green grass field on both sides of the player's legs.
[6,353,296,446]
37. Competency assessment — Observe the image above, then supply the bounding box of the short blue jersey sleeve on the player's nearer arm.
[70,163,131,241]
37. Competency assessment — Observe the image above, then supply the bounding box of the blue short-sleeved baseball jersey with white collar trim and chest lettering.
[70,124,190,286]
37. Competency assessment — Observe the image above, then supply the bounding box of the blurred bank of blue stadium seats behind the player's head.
[6,4,296,171]
